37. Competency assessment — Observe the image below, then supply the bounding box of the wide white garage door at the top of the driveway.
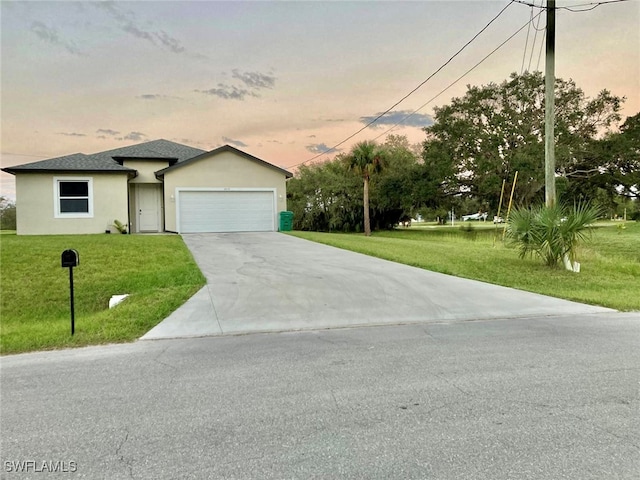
[178,190,275,233]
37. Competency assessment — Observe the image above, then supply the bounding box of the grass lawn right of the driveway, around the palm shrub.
[291,222,640,311]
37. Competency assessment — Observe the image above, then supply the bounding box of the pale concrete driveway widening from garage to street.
[142,233,612,340]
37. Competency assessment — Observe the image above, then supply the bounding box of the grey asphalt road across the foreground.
[0,313,640,480]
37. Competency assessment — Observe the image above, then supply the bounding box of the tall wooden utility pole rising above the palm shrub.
[544,0,556,207]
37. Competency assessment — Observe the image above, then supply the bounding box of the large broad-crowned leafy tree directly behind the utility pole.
[423,72,624,211]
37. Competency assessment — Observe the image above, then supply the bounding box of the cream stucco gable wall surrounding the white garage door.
[164,152,287,232]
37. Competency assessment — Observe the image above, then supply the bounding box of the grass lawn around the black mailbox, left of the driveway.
[0,234,205,354]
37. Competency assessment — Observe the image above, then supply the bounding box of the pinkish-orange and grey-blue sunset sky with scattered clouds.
[0,0,640,198]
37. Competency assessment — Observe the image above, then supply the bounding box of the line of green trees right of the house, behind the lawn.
[287,72,640,233]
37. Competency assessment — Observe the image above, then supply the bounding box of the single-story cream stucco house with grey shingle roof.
[2,140,292,235]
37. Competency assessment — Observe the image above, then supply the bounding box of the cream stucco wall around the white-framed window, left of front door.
[16,173,128,235]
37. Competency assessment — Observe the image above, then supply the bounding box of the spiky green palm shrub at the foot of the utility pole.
[507,203,600,267]
